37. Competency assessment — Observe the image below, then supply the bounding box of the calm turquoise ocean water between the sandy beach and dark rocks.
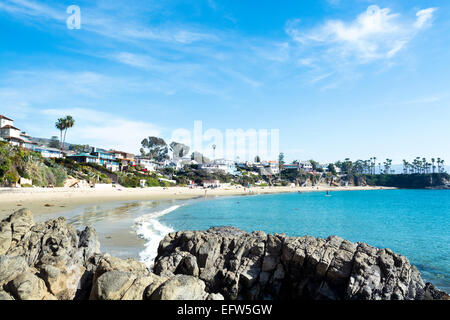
[157,190,450,292]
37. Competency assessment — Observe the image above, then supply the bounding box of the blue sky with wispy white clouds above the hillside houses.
[0,0,450,163]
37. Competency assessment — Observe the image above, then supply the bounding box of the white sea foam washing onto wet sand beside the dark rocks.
[134,205,181,268]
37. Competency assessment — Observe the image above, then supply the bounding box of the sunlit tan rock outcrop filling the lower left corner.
[0,209,219,300]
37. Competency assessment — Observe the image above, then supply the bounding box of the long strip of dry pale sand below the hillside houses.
[0,185,396,217]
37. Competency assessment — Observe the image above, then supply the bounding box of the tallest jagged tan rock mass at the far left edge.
[0,209,100,300]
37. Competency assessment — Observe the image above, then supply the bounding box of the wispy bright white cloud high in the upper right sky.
[286,5,435,63]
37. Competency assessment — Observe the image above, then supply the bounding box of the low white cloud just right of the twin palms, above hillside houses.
[41,108,161,152]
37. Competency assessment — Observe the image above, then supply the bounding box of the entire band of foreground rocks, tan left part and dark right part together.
[0,209,448,300]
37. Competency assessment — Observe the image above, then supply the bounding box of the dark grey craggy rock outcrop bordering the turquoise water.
[154,227,448,300]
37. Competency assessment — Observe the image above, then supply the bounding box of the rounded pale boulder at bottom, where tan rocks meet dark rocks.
[150,274,208,300]
